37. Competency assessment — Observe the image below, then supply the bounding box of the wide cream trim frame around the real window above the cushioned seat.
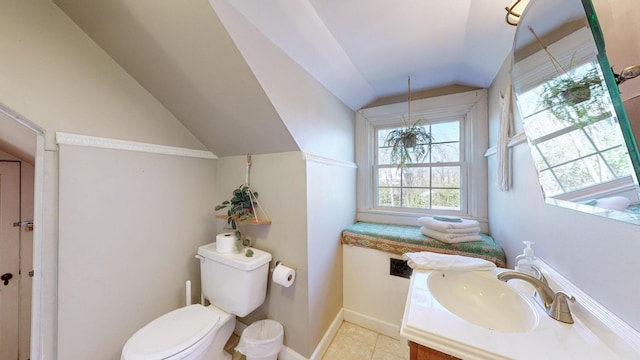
[356,89,489,225]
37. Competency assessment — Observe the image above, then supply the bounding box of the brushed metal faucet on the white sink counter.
[498,271,576,324]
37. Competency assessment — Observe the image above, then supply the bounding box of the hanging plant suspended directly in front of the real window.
[385,117,433,169]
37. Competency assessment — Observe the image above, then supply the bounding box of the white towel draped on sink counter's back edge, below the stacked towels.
[402,251,496,271]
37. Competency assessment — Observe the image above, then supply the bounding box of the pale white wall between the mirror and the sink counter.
[489,58,640,330]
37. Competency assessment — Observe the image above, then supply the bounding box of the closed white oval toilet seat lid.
[122,304,220,360]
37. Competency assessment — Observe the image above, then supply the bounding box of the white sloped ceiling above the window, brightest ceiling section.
[224,0,515,110]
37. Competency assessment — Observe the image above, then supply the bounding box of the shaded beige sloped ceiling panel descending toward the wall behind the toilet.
[55,0,298,156]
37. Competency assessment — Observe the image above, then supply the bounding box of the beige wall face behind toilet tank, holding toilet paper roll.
[217,152,309,353]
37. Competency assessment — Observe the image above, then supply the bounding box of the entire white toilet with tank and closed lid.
[121,243,271,360]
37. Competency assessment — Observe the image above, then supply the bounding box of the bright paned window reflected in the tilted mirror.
[518,61,633,197]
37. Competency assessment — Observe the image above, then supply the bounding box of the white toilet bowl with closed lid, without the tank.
[121,304,235,360]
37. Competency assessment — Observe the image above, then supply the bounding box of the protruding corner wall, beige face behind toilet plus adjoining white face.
[217,152,355,357]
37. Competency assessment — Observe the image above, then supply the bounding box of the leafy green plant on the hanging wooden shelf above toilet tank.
[215,184,258,250]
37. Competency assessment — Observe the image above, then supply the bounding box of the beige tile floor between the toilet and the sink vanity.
[225,321,409,360]
